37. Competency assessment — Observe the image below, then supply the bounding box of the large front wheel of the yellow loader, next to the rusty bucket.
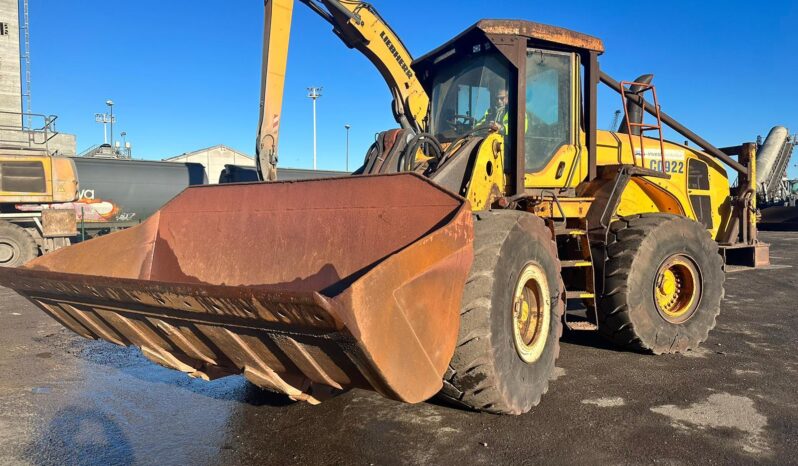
[439,211,565,414]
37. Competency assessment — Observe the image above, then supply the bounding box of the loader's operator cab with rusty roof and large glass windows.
[413,20,604,192]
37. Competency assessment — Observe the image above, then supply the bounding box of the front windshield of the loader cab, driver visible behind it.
[431,52,510,143]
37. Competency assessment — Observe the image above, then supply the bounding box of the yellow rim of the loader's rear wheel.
[654,254,701,323]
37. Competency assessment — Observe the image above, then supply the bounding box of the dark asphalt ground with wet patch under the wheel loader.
[0,232,798,465]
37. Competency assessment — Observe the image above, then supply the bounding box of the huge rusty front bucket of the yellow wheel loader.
[0,174,473,402]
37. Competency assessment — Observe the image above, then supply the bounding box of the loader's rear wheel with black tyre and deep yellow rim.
[598,214,726,354]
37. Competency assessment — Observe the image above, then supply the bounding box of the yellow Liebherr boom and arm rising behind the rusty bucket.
[257,0,429,180]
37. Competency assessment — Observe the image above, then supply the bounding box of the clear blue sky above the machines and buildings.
[30,0,798,177]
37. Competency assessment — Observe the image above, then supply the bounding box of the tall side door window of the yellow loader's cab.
[525,49,573,172]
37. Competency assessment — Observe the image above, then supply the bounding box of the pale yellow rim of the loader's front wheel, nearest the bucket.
[513,263,551,363]
